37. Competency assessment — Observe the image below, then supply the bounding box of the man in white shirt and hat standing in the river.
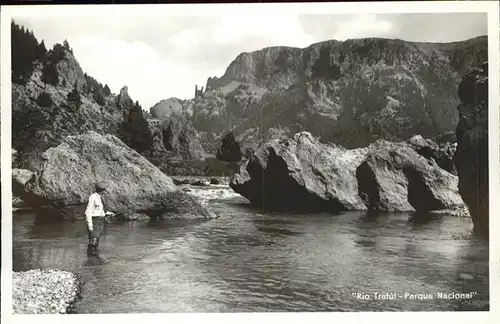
[85,182,114,254]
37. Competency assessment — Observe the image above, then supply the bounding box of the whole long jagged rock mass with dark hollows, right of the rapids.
[230,132,463,211]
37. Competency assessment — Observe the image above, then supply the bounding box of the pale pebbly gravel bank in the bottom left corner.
[12,269,80,314]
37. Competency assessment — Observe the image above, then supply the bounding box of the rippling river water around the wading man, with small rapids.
[13,186,489,313]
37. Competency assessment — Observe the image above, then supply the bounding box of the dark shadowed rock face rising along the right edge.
[454,62,489,236]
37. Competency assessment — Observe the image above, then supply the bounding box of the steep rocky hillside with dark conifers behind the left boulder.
[12,23,203,169]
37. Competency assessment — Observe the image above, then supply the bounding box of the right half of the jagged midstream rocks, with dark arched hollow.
[356,140,463,211]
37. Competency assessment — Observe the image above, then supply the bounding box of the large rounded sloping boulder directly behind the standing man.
[13,132,216,218]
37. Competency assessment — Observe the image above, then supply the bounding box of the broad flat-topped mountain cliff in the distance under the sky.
[153,37,487,153]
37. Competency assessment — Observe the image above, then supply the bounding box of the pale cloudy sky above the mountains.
[9,6,487,110]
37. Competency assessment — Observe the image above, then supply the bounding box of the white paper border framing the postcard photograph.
[0,1,500,324]
